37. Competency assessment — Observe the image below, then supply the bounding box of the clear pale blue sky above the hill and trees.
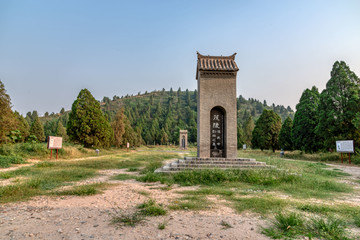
[0,0,360,114]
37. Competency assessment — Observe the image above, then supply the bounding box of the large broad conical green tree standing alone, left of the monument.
[67,89,113,147]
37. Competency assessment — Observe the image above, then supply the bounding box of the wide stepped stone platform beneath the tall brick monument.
[155,157,273,173]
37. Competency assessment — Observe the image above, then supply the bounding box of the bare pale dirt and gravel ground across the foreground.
[0,174,268,239]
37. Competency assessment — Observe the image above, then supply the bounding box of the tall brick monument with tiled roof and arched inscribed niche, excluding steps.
[196,53,239,158]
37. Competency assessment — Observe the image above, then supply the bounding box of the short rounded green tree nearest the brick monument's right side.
[251,109,281,152]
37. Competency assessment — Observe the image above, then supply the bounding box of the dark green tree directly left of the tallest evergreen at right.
[291,86,320,152]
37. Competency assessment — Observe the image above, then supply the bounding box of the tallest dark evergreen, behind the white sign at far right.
[317,61,360,148]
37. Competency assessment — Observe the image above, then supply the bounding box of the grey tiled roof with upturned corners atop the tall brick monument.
[196,52,239,79]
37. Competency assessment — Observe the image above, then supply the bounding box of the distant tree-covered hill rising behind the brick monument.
[42,88,294,144]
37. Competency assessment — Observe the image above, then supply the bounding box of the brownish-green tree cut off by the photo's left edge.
[0,81,16,144]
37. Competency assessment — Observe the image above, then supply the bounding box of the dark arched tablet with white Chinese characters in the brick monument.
[210,107,225,157]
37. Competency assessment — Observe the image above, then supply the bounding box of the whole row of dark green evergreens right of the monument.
[249,61,360,153]
